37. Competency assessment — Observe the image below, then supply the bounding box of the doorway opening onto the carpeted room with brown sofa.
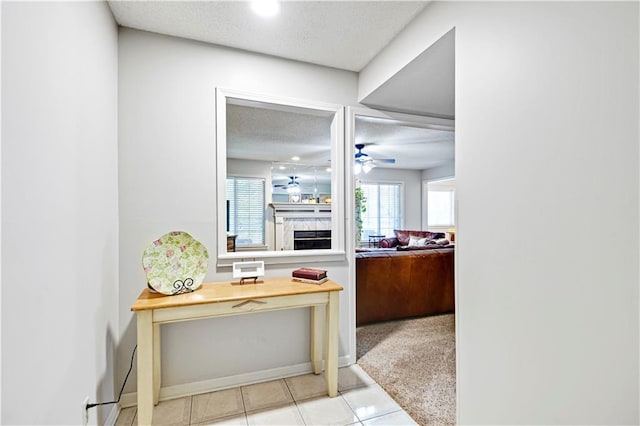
[351,110,456,424]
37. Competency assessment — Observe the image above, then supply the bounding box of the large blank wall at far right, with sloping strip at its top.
[360,2,640,424]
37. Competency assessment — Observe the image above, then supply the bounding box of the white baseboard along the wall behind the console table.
[119,355,353,408]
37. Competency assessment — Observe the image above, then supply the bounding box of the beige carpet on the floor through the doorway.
[356,314,456,425]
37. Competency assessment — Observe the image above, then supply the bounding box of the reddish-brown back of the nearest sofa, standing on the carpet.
[356,231,455,326]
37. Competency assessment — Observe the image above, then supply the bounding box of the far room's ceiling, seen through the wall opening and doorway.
[227,104,454,183]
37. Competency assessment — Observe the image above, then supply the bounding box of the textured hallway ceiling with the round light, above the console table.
[109,1,428,71]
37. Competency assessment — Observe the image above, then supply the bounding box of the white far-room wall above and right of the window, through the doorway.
[358,167,422,233]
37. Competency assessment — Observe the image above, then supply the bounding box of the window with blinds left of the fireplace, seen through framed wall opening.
[227,177,265,246]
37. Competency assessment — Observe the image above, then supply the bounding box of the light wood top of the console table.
[131,278,343,311]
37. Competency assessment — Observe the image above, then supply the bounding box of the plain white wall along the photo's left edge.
[1,2,119,425]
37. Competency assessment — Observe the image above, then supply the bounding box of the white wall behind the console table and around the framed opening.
[118,29,357,397]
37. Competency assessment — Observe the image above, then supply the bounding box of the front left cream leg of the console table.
[137,311,153,425]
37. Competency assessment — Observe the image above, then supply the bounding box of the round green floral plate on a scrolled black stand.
[142,231,209,295]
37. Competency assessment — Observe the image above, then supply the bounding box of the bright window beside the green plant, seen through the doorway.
[360,182,402,241]
